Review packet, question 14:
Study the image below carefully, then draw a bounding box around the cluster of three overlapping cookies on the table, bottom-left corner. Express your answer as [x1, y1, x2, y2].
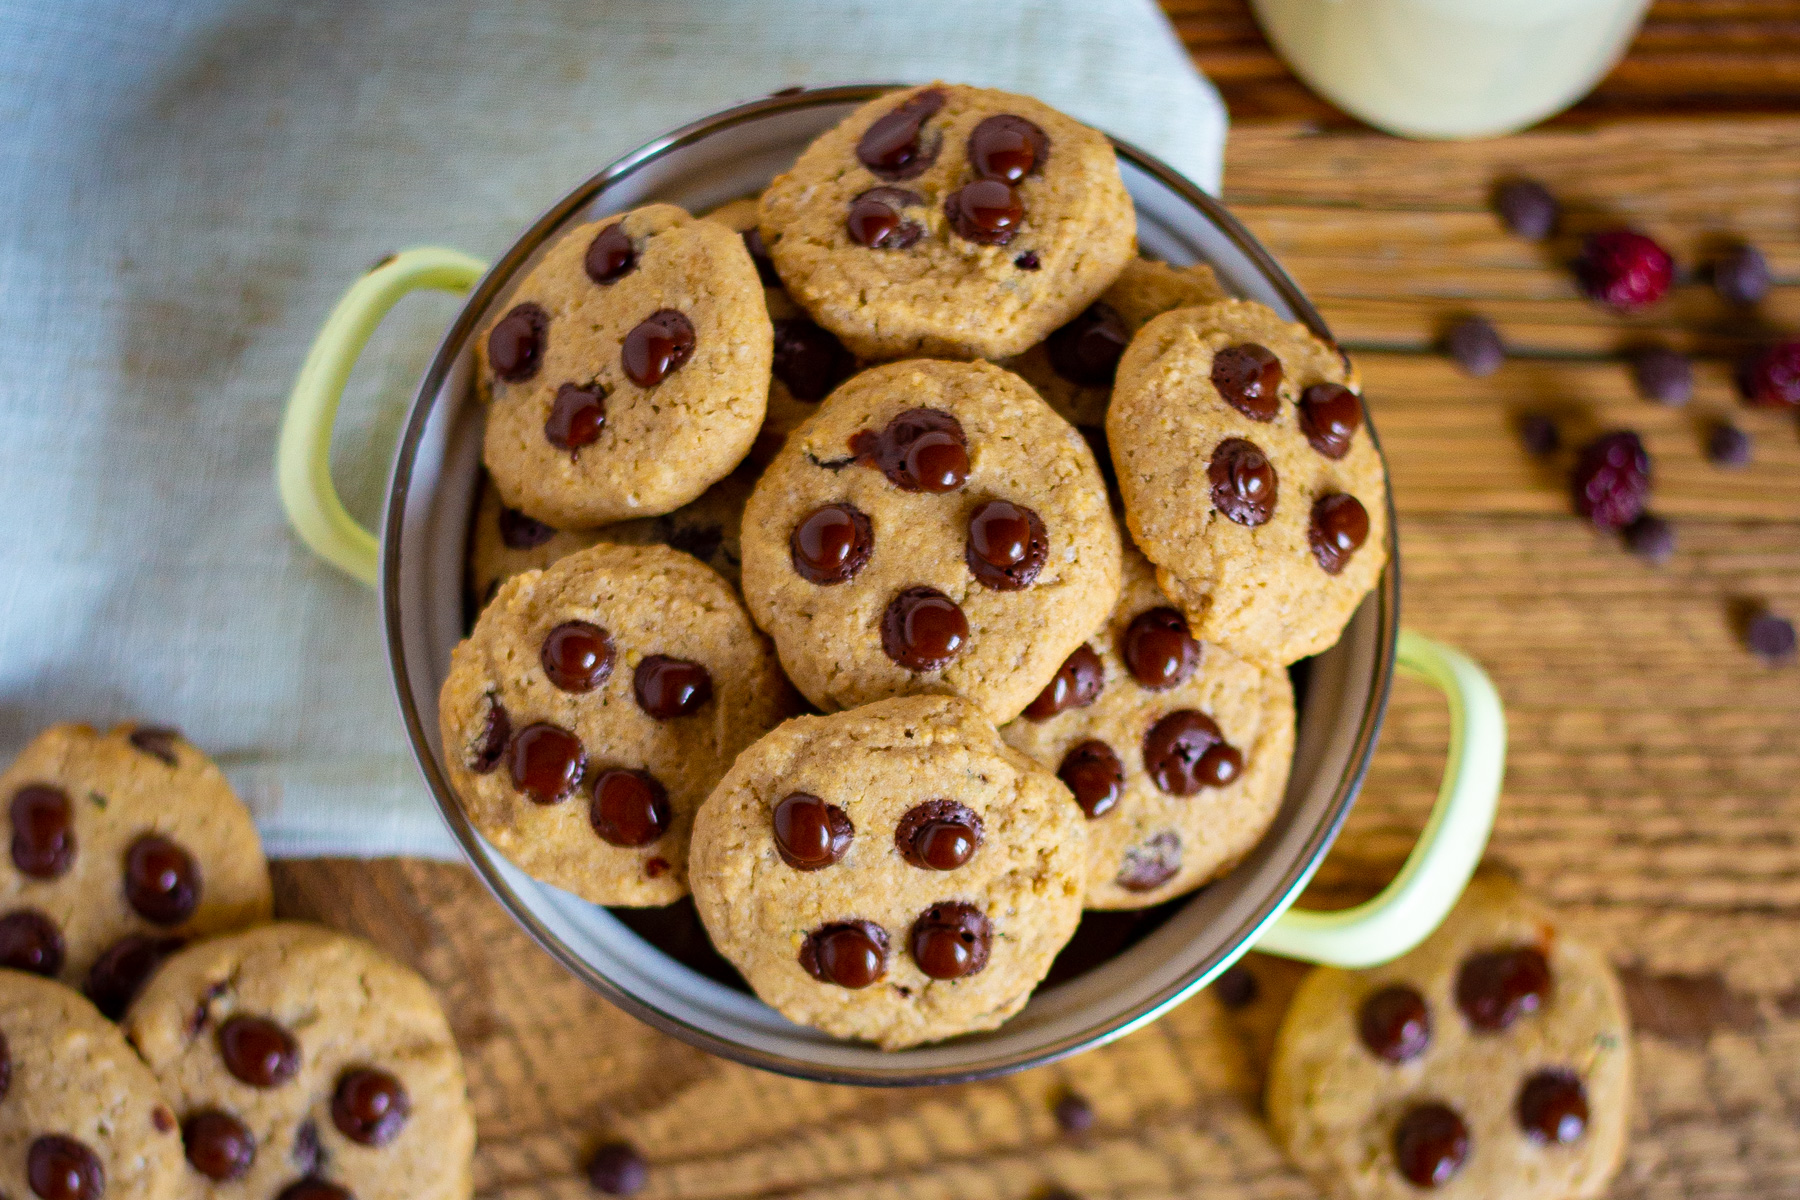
[0, 725, 475, 1200]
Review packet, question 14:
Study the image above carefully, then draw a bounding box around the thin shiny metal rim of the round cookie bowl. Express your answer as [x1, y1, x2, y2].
[380, 83, 1400, 1087]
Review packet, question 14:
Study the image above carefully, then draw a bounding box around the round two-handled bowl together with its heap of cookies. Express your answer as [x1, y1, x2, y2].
[277, 83, 1505, 1085]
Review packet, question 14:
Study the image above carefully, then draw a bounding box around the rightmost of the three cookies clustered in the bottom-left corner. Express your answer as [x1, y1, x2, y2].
[127, 921, 475, 1200]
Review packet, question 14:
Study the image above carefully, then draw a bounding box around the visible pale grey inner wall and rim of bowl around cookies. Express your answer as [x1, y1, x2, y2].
[383, 86, 1399, 1083]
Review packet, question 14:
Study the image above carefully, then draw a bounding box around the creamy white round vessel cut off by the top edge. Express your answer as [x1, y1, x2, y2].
[1251, 0, 1649, 139]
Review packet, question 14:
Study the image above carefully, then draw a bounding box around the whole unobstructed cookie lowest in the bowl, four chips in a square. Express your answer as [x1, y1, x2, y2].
[693, 696, 1085, 1051]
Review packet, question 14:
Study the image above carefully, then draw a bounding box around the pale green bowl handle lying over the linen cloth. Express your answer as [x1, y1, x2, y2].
[275, 246, 488, 587]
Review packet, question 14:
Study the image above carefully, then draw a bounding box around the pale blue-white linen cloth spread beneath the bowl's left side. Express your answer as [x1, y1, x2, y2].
[0, 0, 1226, 856]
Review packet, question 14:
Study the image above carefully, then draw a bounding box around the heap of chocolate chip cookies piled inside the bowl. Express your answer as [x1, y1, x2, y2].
[439, 85, 1388, 1049]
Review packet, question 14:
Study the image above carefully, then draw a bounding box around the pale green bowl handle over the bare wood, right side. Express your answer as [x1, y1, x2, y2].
[1256, 630, 1507, 966]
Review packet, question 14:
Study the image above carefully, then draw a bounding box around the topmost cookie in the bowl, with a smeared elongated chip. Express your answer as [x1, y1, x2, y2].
[760, 83, 1138, 358]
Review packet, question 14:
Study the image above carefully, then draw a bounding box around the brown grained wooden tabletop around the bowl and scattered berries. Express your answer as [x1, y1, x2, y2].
[277, 0, 1800, 1200]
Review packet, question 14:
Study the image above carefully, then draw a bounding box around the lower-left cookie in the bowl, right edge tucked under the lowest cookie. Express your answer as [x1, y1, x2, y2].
[439, 542, 788, 905]
